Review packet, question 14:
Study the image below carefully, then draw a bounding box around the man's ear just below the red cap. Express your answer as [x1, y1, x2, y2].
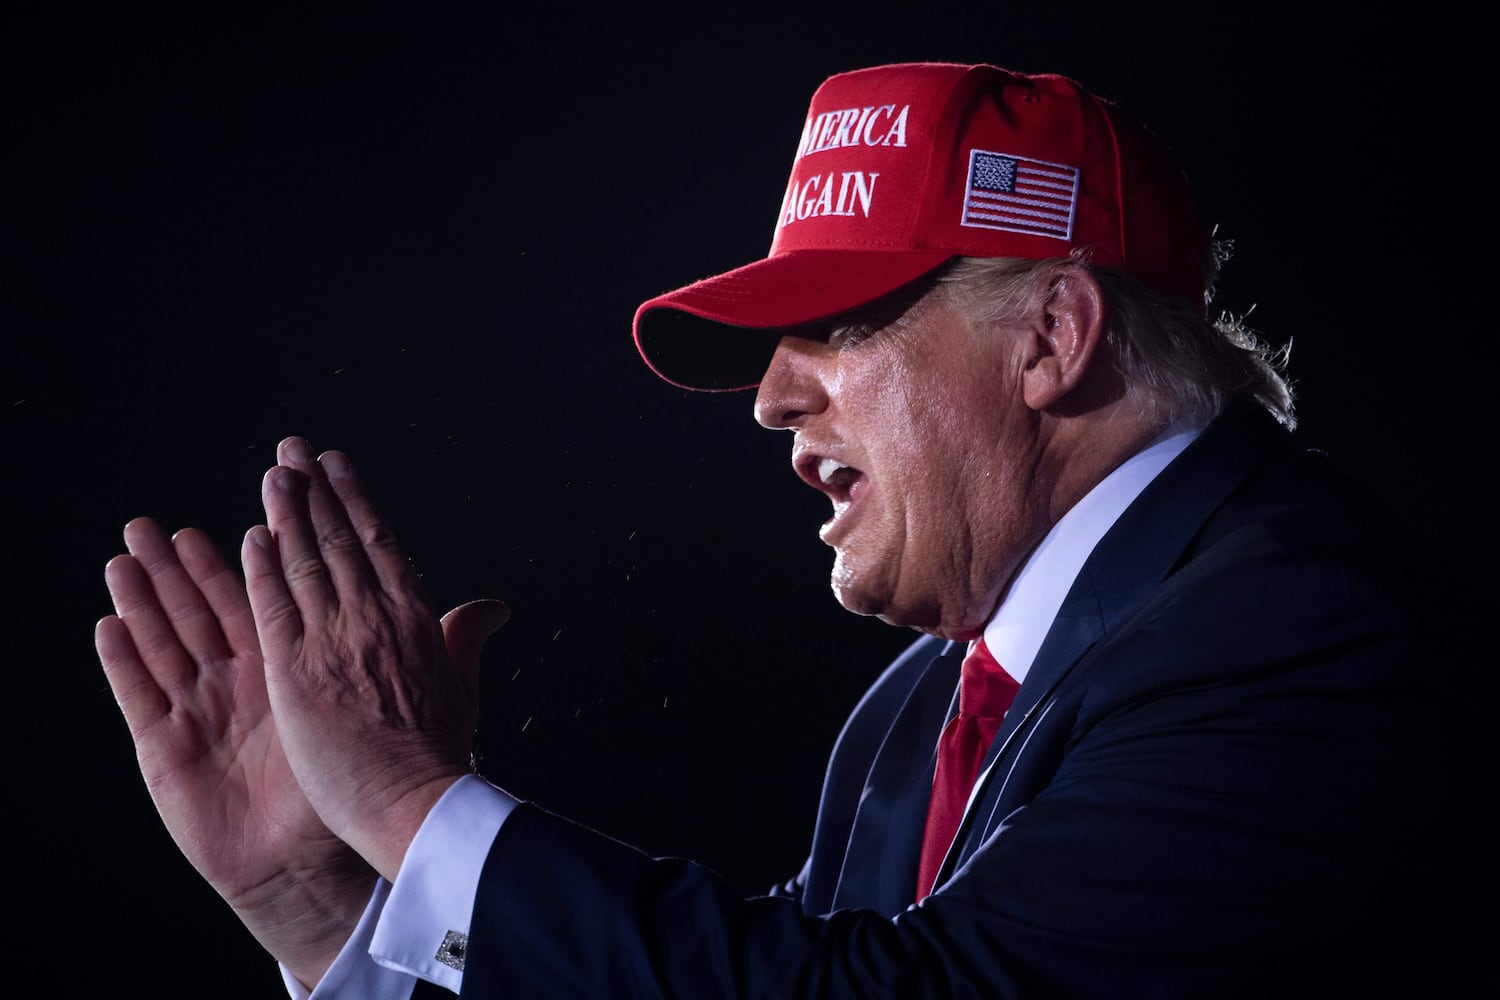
[1022, 267, 1106, 411]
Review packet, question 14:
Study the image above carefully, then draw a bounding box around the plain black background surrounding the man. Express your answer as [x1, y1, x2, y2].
[0, 3, 1494, 997]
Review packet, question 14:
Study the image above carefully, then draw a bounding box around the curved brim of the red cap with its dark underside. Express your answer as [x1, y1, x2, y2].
[635, 250, 953, 391]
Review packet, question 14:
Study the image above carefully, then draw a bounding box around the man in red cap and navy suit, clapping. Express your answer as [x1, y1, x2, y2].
[98, 64, 1490, 999]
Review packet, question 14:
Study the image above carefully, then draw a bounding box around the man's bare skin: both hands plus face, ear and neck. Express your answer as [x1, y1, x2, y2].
[96, 265, 1160, 987]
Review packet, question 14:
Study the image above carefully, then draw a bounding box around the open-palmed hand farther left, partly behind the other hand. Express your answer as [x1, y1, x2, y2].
[95, 517, 375, 985]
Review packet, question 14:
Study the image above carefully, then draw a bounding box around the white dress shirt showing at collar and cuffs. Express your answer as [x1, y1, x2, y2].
[292, 429, 1199, 1000]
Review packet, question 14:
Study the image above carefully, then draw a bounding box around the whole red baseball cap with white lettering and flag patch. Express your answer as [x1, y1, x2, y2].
[635, 63, 1209, 390]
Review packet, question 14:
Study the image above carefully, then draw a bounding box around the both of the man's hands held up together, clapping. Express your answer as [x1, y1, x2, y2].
[96, 438, 509, 988]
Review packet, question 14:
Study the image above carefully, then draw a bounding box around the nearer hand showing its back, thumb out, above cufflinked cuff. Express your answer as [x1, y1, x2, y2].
[242, 438, 509, 879]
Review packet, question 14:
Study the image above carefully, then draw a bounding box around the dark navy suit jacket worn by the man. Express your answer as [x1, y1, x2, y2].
[461, 406, 1496, 1000]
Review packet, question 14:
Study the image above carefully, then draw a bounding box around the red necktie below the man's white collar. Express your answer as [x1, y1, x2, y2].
[917, 639, 1020, 901]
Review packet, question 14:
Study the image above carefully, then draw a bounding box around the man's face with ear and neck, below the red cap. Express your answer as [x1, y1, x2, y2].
[756, 265, 1158, 639]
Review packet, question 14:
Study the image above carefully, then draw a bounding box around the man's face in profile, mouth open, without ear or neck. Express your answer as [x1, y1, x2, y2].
[756, 281, 1047, 639]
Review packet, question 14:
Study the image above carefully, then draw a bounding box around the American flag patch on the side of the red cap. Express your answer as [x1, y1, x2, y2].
[963, 150, 1079, 240]
